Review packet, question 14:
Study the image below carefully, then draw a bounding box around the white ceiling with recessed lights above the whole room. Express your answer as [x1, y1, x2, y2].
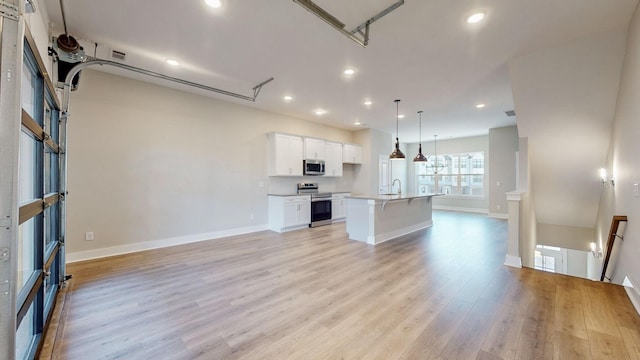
[38, 0, 637, 142]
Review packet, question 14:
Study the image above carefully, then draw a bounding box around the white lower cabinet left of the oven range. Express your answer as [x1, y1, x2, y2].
[269, 195, 311, 232]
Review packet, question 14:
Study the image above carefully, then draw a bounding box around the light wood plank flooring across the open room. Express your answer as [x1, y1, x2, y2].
[41, 212, 640, 360]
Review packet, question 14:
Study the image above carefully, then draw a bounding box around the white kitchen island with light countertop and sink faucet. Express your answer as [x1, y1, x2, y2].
[346, 194, 440, 245]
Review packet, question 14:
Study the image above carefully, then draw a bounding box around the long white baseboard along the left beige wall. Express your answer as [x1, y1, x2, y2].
[66, 224, 268, 264]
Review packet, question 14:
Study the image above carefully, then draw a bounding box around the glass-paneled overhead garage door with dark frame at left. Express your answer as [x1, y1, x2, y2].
[15, 30, 64, 359]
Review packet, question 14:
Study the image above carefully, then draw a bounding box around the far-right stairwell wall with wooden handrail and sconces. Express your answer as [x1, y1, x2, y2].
[592, 4, 640, 303]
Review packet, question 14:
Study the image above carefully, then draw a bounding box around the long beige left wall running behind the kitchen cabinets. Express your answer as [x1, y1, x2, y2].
[67, 70, 357, 260]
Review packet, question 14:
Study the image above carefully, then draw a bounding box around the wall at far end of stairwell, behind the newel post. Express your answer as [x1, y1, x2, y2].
[509, 28, 627, 227]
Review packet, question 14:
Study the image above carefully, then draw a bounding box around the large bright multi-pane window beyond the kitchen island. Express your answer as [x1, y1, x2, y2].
[415, 152, 485, 197]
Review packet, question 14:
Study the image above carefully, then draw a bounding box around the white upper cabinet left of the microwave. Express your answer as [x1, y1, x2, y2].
[268, 133, 303, 176]
